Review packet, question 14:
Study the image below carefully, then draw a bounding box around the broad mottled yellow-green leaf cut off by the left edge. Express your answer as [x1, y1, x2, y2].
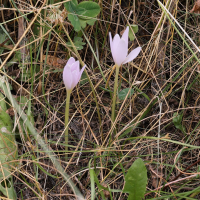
[0, 93, 17, 199]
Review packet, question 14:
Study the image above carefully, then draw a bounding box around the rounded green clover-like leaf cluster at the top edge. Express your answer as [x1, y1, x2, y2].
[64, 0, 100, 32]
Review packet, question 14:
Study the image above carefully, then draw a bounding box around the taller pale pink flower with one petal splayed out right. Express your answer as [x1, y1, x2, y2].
[109, 27, 141, 67]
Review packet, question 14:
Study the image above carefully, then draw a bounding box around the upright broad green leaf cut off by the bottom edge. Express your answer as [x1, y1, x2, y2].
[123, 158, 147, 200]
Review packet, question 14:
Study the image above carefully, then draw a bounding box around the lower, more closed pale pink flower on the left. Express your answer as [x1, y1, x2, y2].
[63, 57, 86, 91]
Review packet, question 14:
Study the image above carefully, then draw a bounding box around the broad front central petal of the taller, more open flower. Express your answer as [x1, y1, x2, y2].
[113, 38, 128, 67]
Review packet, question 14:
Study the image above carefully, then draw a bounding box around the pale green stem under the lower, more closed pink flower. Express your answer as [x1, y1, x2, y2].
[65, 90, 71, 161]
